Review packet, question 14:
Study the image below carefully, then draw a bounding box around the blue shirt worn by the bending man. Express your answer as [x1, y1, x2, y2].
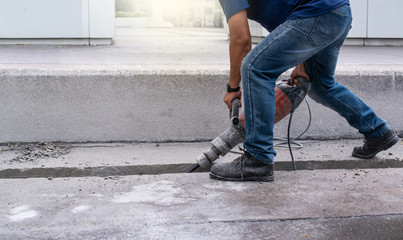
[220, 0, 350, 31]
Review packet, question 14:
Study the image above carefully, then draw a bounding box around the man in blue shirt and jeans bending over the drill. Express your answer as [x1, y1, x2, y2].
[210, 0, 399, 181]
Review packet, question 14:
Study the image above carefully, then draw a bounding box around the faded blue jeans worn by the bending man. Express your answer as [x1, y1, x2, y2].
[241, 5, 390, 163]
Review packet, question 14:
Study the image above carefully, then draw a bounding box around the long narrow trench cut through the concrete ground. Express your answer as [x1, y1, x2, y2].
[0, 159, 403, 179]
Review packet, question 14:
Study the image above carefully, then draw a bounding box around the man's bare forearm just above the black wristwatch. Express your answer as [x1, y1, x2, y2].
[229, 38, 252, 88]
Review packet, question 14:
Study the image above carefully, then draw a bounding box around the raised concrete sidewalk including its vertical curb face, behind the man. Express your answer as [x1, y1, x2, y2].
[0, 28, 403, 142]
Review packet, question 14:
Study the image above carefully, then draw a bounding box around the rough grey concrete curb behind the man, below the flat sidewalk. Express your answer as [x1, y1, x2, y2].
[0, 65, 403, 142]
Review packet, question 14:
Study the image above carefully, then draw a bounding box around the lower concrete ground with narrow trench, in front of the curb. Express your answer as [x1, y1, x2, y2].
[0, 140, 403, 240]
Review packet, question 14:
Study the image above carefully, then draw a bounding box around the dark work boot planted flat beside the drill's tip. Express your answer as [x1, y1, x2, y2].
[210, 151, 274, 182]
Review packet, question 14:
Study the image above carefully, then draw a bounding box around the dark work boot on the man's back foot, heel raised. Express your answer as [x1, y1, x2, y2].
[353, 130, 399, 159]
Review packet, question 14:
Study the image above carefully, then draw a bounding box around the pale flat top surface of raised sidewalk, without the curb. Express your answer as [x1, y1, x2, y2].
[0, 28, 403, 67]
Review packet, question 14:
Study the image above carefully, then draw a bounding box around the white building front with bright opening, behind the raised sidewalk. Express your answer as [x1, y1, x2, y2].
[0, 0, 403, 46]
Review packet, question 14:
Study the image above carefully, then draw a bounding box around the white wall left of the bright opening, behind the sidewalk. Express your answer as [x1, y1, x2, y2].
[0, 0, 115, 43]
